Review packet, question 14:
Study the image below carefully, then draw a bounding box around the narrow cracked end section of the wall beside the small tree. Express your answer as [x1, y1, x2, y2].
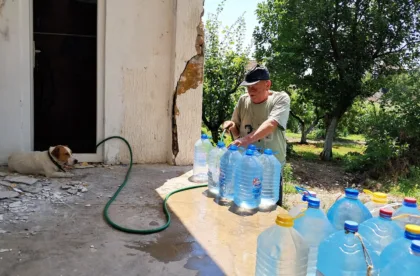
[170, 0, 204, 165]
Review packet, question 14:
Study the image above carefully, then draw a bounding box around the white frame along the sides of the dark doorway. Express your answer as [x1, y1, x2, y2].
[29, 0, 106, 162]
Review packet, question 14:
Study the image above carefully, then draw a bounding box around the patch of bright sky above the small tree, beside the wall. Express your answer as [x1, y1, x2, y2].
[203, 0, 263, 52]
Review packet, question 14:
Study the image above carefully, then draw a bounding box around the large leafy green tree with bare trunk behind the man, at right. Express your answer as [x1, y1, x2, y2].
[254, 0, 420, 160]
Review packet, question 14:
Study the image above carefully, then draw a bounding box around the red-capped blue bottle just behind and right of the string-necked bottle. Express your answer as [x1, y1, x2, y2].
[359, 208, 404, 256]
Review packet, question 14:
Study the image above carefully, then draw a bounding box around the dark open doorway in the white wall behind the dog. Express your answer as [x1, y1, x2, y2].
[33, 0, 97, 153]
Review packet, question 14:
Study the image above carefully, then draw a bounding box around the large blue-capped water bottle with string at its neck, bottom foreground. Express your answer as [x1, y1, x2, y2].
[317, 221, 379, 276]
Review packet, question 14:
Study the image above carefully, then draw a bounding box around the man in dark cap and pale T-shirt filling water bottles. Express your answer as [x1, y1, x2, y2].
[223, 65, 290, 206]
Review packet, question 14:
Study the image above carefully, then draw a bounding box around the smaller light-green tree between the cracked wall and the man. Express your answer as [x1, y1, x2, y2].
[202, 0, 250, 142]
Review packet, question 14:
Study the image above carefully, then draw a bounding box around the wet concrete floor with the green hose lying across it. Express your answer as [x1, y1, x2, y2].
[0, 165, 283, 276]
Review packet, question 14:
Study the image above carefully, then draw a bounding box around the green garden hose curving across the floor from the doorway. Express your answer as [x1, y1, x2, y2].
[96, 136, 207, 234]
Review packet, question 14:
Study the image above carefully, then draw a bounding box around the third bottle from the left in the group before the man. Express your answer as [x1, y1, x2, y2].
[219, 145, 242, 201]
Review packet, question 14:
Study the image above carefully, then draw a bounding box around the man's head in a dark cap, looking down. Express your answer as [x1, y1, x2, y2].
[241, 64, 271, 104]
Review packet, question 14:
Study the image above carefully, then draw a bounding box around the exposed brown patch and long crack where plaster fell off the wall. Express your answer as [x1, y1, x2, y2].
[172, 9, 204, 165]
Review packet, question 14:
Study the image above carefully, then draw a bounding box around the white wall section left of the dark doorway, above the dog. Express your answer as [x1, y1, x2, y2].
[0, 0, 32, 164]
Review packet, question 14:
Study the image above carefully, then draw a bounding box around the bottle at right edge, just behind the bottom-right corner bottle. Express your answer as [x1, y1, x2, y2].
[380, 224, 420, 268]
